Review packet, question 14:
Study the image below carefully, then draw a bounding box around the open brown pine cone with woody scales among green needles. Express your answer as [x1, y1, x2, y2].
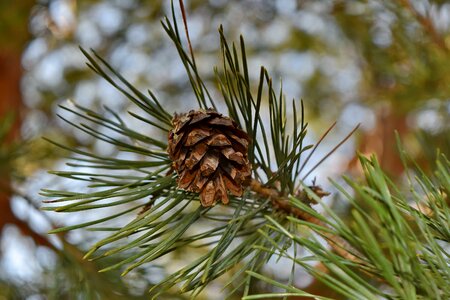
[167, 109, 251, 206]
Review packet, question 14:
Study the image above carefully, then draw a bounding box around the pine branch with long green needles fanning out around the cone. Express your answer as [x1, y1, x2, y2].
[41, 4, 364, 297]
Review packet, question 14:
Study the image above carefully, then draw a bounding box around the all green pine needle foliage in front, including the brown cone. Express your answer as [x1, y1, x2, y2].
[42, 1, 450, 299]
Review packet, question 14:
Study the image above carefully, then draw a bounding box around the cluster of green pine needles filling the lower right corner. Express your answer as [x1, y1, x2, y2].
[247, 149, 450, 299]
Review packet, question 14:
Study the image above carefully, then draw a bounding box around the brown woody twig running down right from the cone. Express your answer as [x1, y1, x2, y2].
[249, 179, 362, 264]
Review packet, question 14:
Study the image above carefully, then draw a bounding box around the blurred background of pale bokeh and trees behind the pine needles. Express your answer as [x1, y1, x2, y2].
[0, 0, 450, 300]
